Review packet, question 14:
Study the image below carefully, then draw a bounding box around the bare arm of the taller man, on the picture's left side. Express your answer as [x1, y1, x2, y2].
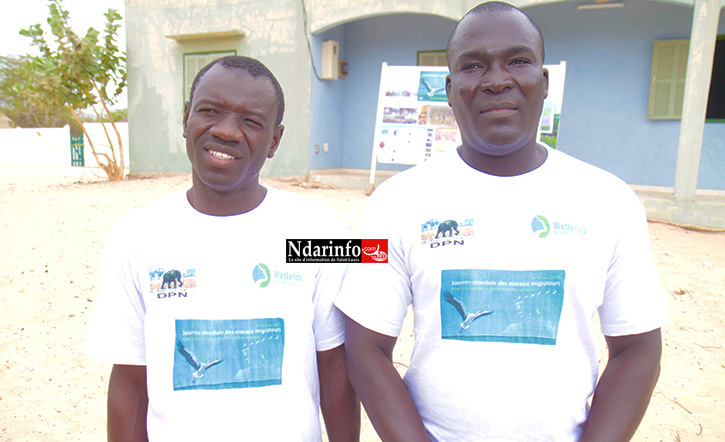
[345, 318, 430, 442]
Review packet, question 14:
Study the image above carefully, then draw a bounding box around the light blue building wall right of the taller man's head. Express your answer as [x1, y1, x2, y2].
[527, 2, 725, 189]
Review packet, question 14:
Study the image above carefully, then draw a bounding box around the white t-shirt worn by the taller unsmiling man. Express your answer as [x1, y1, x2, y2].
[336, 149, 667, 441]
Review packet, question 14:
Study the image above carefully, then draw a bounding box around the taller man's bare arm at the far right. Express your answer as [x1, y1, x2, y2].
[580, 328, 662, 442]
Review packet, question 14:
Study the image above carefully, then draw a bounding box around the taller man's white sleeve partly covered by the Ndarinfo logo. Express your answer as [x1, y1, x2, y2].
[335, 187, 412, 336]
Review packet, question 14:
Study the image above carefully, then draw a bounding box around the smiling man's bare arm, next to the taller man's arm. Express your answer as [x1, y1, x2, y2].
[317, 344, 360, 442]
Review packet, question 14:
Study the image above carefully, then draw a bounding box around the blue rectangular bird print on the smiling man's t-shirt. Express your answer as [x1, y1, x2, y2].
[173, 318, 284, 390]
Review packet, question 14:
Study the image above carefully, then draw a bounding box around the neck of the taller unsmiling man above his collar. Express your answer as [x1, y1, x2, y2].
[458, 143, 549, 176]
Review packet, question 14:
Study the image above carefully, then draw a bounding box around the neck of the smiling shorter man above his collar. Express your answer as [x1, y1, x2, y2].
[186, 182, 267, 216]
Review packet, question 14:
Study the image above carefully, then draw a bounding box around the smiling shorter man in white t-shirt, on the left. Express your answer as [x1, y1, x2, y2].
[85, 56, 360, 441]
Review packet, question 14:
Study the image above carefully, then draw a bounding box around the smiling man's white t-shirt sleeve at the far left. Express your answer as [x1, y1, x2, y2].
[83, 218, 146, 365]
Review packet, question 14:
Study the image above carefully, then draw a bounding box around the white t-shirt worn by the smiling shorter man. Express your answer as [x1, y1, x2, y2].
[84, 189, 345, 441]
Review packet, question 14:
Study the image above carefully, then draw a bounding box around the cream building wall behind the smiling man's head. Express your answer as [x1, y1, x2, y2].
[126, 0, 310, 175]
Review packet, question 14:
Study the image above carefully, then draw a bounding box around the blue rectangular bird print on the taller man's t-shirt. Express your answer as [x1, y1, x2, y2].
[440, 269, 565, 345]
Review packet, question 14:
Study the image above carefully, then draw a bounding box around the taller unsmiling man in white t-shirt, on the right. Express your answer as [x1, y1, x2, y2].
[335, 2, 667, 442]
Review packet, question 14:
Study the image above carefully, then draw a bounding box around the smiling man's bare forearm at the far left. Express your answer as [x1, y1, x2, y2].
[108, 364, 149, 442]
